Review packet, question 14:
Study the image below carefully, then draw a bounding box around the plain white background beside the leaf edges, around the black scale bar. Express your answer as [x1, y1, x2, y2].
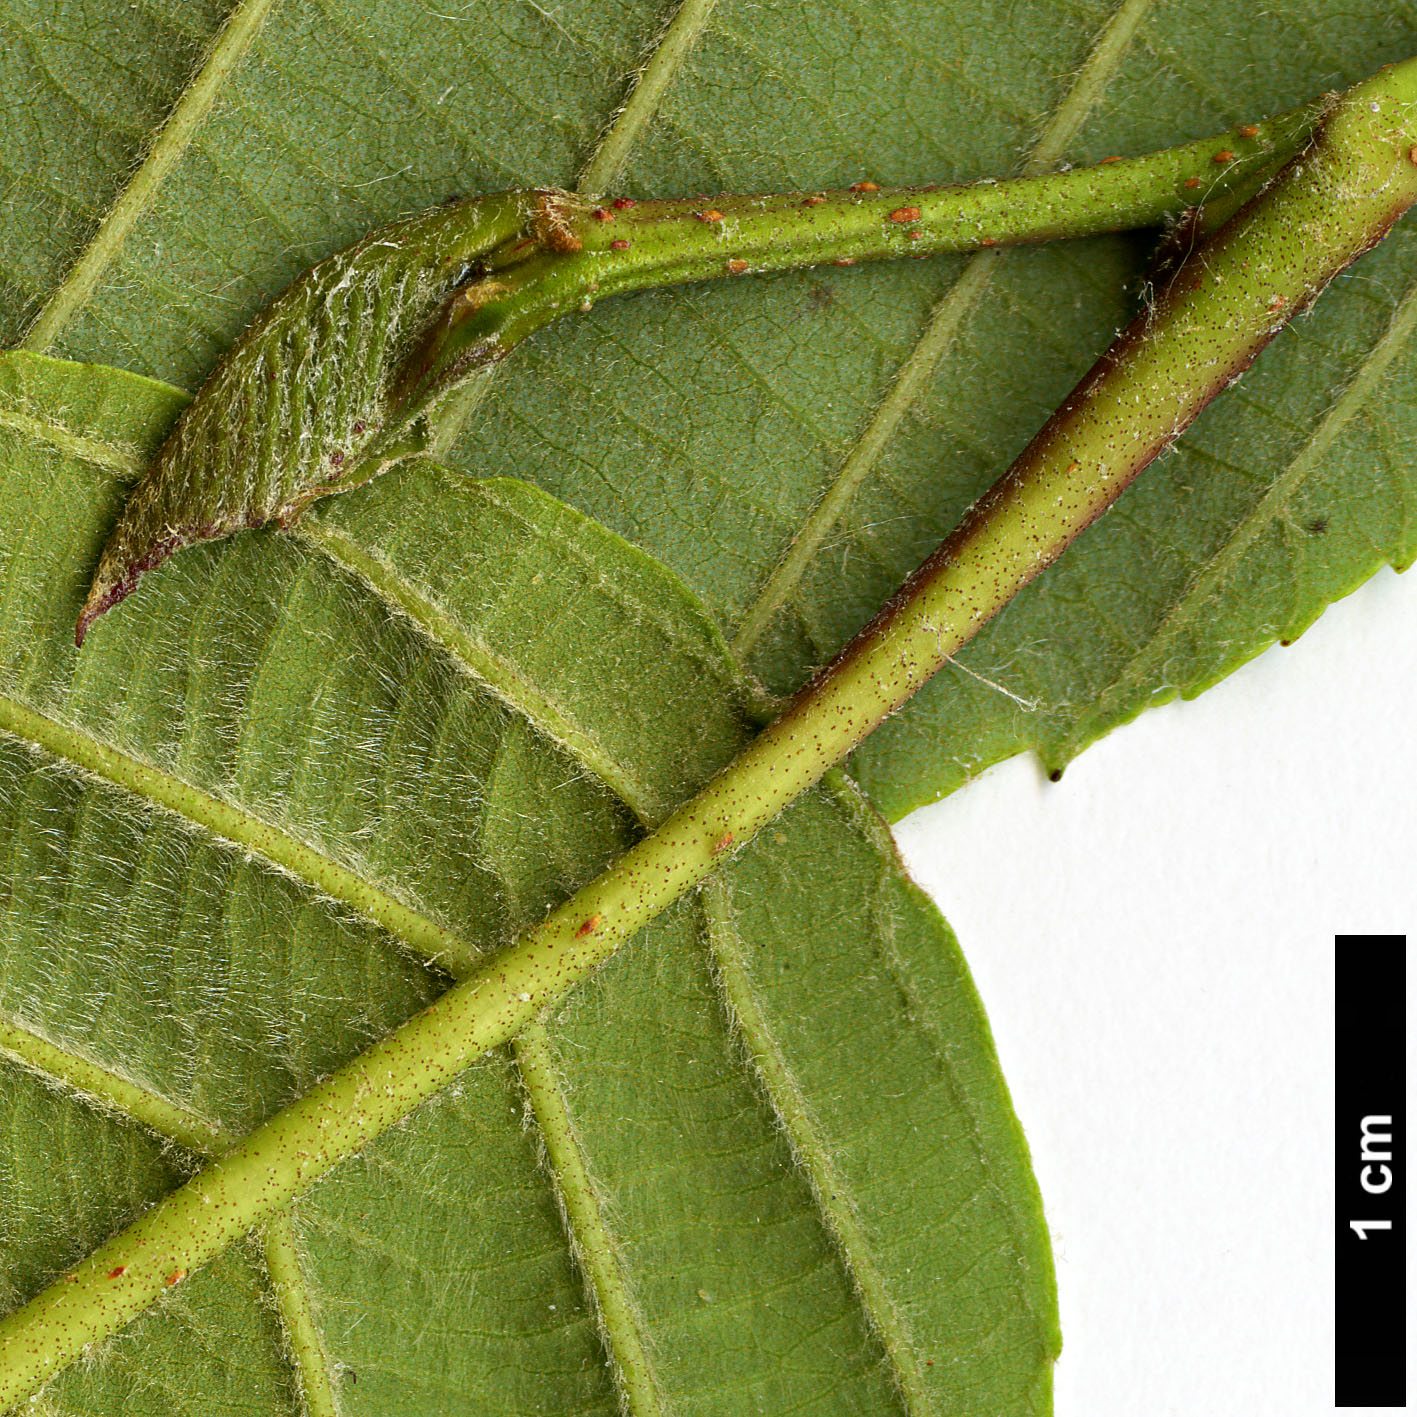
[897, 558, 1417, 1417]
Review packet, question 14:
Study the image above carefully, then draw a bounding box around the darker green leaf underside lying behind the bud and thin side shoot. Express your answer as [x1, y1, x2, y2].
[4, 0, 1417, 816]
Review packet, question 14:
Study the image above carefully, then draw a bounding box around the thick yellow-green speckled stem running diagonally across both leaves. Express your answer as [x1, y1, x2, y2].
[0, 52, 1417, 1410]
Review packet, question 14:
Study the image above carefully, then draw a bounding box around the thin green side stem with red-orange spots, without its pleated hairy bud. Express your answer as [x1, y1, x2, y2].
[404, 102, 1323, 411]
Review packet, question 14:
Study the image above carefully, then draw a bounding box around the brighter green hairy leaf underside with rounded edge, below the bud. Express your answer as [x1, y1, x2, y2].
[0, 354, 1057, 1413]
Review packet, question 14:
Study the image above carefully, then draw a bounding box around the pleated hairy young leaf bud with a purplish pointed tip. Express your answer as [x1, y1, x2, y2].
[75, 194, 530, 645]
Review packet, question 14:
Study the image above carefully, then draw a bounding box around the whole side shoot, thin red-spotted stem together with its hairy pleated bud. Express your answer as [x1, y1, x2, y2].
[75, 94, 1321, 645]
